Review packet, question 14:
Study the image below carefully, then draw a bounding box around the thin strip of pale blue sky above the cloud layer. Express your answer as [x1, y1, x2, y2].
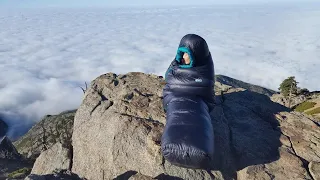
[0, 0, 318, 8]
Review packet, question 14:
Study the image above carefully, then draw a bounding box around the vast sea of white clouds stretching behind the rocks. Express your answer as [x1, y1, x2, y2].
[0, 7, 320, 137]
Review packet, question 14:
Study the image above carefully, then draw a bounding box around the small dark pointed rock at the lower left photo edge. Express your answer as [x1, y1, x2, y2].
[0, 136, 21, 160]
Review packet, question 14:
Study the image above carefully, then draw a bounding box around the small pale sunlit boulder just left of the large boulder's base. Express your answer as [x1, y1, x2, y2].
[31, 143, 72, 175]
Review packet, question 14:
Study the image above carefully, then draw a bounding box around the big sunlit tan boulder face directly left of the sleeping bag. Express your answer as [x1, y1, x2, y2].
[72, 73, 165, 179]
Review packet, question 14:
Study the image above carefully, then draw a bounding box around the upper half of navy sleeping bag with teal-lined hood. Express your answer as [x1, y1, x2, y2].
[163, 34, 215, 111]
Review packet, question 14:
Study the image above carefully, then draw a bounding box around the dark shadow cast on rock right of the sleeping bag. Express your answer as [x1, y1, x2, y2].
[211, 91, 290, 179]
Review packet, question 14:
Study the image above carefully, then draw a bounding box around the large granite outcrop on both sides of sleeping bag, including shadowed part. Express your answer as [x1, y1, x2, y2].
[66, 73, 320, 179]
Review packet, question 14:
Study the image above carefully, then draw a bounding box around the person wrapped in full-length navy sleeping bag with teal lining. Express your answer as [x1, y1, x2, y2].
[161, 34, 214, 169]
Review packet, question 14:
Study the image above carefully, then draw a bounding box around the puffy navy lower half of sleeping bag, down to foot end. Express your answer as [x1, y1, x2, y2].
[161, 96, 214, 169]
